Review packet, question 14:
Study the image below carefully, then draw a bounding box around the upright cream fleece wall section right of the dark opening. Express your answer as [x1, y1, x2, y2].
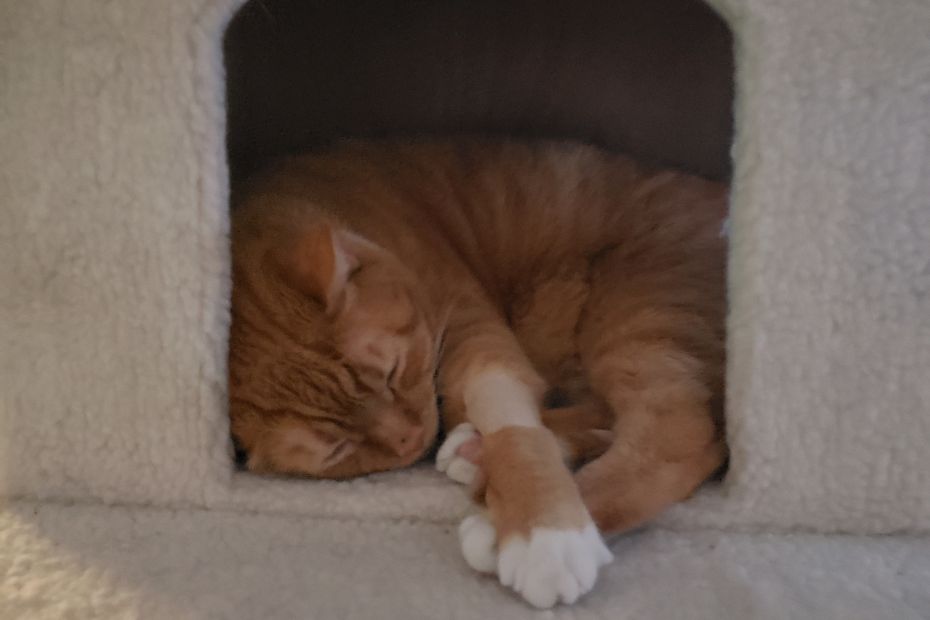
[719, 0, 930, 532]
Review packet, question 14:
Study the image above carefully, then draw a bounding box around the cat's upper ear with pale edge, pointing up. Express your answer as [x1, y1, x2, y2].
[279, 222, 359, 312]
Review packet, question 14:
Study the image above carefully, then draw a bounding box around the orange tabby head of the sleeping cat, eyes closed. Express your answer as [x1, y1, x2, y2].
[229, 213, 441, 478]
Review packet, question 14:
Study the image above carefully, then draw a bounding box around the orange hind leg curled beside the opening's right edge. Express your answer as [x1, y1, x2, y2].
[576, 216, 726, 532]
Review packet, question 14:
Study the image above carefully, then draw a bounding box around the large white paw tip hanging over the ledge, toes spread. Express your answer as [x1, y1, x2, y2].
[496, 523, 613, 609]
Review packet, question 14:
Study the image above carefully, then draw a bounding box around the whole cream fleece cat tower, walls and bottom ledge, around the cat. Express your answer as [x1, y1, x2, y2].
[0, 0, 930, 620]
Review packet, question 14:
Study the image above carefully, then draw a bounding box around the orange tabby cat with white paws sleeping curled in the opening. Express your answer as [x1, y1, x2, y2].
[229, 139, 726, 607]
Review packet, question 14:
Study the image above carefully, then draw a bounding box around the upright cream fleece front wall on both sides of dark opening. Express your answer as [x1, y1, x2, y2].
[0, 0, 930, 588]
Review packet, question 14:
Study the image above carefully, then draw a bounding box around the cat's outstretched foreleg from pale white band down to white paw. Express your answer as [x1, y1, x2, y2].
[460, 368, 612, 608]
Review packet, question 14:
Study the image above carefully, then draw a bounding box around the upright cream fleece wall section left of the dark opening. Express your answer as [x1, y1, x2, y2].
[0, 0, 233, 502]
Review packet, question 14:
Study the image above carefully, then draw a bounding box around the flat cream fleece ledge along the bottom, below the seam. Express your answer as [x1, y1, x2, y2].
[0, 502, 930, 620]
